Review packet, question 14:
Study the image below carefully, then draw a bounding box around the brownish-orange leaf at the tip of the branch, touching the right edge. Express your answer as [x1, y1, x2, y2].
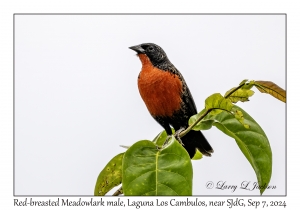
[255, 81, 286, 102]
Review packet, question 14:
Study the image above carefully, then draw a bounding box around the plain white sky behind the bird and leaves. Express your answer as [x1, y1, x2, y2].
[15, 15, 286, 195]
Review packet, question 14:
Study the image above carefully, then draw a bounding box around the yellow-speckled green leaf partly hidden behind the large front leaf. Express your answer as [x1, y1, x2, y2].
[94, 153, 124, 196]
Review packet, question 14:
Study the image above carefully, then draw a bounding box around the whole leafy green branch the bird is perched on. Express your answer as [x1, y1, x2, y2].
[94, 80, 286, 195]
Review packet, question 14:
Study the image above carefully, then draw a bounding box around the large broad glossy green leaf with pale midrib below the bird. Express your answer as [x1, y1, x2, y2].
[123, 136, 193, 195]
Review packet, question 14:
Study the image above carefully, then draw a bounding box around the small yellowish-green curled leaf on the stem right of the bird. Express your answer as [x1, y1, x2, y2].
[205, 93, 233, 115]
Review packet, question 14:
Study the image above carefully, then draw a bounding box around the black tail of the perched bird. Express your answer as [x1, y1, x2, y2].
[181, 130, 214, 158]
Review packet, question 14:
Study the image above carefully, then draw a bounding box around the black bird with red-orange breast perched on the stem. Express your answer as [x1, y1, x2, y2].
[129, 43, 213, 158]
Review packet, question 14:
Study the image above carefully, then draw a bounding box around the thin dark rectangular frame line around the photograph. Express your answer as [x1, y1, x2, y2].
[13, 13, 287, 197]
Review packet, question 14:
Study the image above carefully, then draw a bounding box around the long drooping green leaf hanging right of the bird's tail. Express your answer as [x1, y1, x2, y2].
[214, 106, 272, 194]
